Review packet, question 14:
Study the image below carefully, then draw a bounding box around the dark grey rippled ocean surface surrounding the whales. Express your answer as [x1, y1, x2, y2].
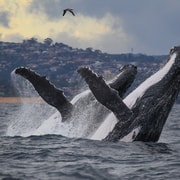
[0, 104, 180, 180]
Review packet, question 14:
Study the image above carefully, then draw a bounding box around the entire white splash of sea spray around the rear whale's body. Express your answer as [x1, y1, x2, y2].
[7, 72, 108, 138]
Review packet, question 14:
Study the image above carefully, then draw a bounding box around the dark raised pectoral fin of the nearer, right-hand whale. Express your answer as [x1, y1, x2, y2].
[78, 67, 132, 121]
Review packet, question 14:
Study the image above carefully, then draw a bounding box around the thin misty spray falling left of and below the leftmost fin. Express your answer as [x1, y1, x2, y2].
[6, 71, 55, 136]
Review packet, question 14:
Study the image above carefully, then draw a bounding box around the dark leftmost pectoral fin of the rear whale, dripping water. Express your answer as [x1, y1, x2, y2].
[15, 68, 73, 117]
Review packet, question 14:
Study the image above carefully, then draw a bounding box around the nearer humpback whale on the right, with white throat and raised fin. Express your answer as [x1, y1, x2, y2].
[78, 47, 180, 142]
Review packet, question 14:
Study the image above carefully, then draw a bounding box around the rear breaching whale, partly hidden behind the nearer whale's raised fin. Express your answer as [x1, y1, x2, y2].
[15, 65, 137, 137]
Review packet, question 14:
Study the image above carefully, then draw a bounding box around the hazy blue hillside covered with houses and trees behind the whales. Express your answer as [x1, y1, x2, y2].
[0, 38, 167, 96]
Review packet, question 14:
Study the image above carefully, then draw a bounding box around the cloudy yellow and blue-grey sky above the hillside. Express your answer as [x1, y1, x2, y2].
[0, 0, 180, 55]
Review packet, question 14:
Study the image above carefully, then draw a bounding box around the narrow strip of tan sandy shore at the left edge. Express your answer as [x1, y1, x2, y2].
[0, 97, 44, 104]
